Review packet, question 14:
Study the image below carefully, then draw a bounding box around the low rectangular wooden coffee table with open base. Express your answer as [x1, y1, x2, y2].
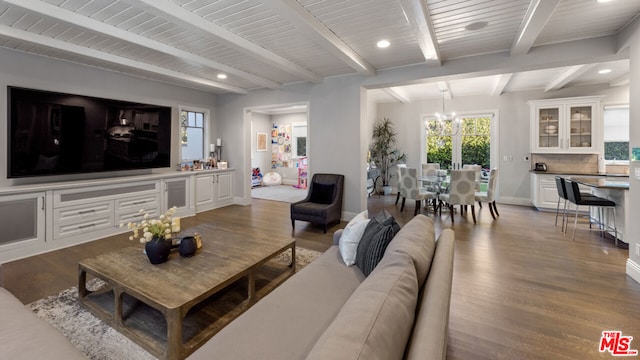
[78, 230, 296, 359]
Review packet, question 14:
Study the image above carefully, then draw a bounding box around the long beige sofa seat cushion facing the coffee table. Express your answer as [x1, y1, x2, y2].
[189, 246, 364, 360]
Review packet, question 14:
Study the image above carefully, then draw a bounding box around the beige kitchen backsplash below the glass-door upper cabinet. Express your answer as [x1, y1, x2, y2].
[531, 154, 598, 174]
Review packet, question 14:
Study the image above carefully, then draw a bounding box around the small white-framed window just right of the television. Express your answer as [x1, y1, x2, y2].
[180, 110, 206, 161]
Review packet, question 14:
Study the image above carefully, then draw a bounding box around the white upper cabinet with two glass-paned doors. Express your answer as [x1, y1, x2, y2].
[529, 96, 602, 154]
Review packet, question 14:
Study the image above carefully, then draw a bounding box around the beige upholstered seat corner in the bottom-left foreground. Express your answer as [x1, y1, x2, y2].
[0, 288, 86, 360]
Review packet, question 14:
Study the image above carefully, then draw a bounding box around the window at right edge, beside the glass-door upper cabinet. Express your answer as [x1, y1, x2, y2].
[603, 105, 629, 162]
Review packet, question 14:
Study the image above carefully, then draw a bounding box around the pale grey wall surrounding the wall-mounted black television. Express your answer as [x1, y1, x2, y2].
[0, 48, 216, 187]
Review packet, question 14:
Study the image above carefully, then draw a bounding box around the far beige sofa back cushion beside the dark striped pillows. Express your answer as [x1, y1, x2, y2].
[386, 214, 436, 286]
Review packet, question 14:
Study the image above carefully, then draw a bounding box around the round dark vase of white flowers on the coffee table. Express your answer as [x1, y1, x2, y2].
[120, 206, 180, 265]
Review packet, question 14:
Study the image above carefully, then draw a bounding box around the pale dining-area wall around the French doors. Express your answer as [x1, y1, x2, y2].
[377, 85, 629, 205]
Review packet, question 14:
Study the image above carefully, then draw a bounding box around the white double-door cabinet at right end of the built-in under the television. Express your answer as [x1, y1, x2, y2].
[195, 171, 233, 212]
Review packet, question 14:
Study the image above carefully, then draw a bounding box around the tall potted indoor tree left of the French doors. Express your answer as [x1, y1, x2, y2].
[369, 118, 407, 195]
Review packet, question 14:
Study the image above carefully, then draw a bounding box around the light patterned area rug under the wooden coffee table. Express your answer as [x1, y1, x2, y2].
[27, 248, 320, 360]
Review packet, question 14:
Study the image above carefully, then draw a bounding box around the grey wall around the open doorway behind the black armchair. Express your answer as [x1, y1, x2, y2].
[216, 76, 366, 217]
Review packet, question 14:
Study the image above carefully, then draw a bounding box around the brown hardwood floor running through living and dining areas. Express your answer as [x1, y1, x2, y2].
[3, 195, 640, 360]
